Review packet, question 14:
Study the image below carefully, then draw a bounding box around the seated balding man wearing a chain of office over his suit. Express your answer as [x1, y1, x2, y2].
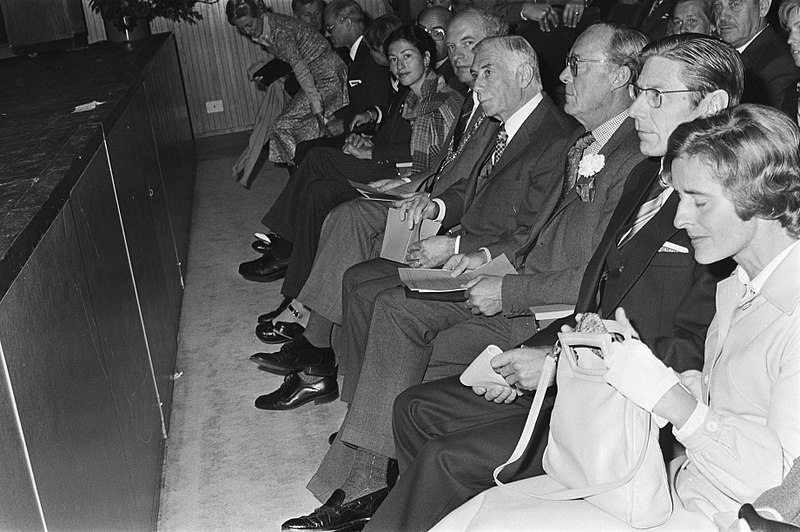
[251, 10, 508, 390]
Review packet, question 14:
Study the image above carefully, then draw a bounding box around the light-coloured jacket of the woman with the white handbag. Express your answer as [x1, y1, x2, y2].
[675, 246, 800, 528]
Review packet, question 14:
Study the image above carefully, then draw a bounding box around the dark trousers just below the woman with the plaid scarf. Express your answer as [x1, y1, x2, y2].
[261, 148, 396, 297]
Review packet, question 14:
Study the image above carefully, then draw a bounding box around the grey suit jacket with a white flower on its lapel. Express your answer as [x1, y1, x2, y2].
[504, 118, 644, 318]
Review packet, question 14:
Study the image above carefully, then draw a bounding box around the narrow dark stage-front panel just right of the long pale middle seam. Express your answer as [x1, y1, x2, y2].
[106, 89, 183, 428]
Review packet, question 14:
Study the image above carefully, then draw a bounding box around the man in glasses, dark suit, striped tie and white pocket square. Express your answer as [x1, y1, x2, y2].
[371, 35, 744, 530]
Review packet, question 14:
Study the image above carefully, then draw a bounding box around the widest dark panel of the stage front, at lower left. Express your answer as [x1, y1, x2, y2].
[0, 203, 140, 530]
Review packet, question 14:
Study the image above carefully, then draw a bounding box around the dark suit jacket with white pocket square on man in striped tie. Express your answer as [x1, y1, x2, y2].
[524, 158, 735, 371]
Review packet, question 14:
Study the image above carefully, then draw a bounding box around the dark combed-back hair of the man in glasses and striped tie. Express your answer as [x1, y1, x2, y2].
[639, 33, 744, 105]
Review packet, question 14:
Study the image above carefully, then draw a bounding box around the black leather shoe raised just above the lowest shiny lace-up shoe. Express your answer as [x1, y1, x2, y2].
[250, 334, 336, 376]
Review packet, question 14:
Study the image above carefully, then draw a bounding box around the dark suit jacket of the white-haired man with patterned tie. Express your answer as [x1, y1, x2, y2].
[438, 93, 576, 256]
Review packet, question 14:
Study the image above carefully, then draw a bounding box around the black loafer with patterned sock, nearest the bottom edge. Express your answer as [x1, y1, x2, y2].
[281, 488, 389, 532]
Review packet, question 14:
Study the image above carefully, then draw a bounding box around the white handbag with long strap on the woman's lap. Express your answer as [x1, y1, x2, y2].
[494, 321, 672, 528]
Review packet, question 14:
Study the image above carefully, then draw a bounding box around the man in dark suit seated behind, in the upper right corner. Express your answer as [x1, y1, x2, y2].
[714, 0, 800, 113]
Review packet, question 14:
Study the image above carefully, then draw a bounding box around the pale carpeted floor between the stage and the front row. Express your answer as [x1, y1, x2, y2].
[159, 134, 345, 531]
